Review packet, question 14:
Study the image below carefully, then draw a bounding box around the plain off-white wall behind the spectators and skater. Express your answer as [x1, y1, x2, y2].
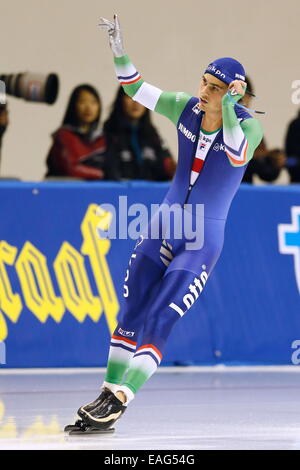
[0, 0, 300, 180]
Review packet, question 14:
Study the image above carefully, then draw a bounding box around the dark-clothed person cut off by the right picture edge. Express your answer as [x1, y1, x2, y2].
[285, 111, 300, 183]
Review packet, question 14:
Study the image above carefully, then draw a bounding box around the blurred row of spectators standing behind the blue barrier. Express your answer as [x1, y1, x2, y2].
[0, 77, 300, 184]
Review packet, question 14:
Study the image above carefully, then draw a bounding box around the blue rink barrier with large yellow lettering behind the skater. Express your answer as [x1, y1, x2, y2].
[0, 182, 300, 368]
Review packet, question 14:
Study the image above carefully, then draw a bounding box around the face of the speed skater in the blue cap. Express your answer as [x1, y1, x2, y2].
[198, 73, 228, 113]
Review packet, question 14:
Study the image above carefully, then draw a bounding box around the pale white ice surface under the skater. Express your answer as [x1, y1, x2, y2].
[0, 366, 300, 451]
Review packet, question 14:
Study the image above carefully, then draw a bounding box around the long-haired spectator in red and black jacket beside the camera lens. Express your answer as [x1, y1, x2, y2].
[46, 85, 110, 180]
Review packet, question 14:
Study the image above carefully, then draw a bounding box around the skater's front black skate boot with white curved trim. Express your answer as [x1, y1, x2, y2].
[82, 392, 126, 430]
